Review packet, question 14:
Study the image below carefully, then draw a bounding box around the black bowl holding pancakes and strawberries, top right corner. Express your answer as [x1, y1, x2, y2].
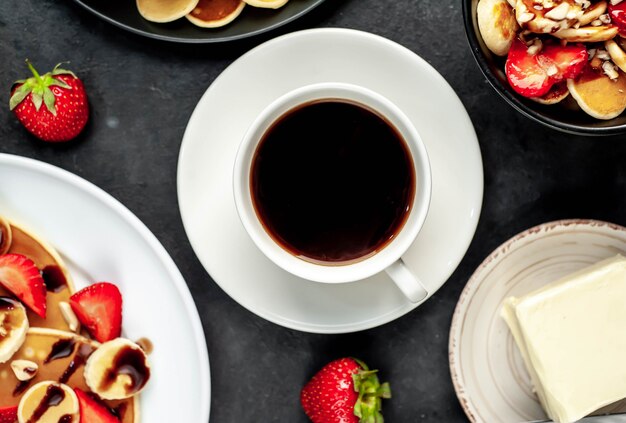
[463, 0, 626, 135]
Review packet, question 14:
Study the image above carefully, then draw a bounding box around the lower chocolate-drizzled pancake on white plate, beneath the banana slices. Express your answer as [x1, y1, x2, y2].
[0, 328, 139, 423]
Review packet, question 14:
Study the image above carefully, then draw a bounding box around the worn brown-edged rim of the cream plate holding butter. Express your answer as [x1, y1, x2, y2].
[448, 219, 626, 423]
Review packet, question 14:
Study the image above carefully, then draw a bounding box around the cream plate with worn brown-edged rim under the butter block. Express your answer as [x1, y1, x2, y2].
[450, 220, 626, 423]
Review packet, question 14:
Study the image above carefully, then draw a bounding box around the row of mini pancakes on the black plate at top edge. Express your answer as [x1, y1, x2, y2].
[137, 0, 289, 28]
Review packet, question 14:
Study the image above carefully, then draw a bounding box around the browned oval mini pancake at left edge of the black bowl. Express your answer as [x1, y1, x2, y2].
[478, 0, 519, 56]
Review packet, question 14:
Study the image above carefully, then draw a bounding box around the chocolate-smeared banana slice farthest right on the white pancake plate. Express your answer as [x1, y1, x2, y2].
[85, 338, 150, 400]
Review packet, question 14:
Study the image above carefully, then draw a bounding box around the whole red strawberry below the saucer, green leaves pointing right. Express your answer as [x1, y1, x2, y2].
[300, 358, 391, 423]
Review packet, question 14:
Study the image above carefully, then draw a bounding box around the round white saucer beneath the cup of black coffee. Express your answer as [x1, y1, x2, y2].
[178, 28, 483, 333]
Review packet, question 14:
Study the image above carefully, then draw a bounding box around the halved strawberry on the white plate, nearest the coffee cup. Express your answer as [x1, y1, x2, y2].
[70, 282, 122, 342]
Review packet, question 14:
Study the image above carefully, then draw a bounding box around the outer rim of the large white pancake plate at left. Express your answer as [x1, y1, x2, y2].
[0, 153, 211, 423]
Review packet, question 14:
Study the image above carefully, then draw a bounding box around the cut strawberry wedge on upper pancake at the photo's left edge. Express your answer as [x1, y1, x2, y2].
[0, 254, 47, 318]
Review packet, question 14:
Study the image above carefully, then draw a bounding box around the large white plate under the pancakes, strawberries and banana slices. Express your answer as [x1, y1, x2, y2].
[0, 154, 210, 423]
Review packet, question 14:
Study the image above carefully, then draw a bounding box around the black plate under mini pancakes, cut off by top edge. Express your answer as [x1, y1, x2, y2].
[74, 0, 324, 43]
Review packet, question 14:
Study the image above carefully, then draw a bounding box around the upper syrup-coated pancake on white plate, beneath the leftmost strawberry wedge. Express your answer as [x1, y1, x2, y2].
[0, 218, 75, 330]
